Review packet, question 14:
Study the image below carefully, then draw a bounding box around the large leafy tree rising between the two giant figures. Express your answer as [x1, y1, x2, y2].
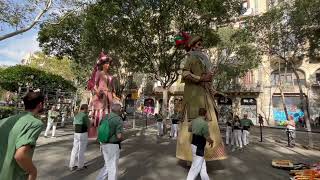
[39, 0, 245, 116]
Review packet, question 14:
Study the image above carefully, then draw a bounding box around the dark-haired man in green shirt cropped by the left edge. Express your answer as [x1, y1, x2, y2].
[0, 92, 44, 180]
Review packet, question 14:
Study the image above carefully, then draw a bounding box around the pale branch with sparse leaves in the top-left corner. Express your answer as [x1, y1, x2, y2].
[0, 0, 90, 41]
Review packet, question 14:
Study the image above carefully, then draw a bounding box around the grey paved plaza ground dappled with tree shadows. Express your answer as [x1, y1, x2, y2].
[34, 127, 320, 180]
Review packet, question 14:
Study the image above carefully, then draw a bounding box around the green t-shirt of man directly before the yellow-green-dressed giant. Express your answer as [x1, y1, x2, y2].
[191, 116, 209, 138]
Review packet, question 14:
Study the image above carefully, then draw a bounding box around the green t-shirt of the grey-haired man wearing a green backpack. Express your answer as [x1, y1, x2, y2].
[107, 112, 123, 143]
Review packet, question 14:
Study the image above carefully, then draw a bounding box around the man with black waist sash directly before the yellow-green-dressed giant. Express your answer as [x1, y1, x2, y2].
[187, 108, 213, 180]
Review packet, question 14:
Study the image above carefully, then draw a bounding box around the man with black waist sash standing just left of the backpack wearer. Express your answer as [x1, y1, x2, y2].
[69, 104, 90, 171]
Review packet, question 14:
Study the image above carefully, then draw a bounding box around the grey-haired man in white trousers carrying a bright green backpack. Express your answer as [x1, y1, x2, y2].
[97, 104, 123, 180]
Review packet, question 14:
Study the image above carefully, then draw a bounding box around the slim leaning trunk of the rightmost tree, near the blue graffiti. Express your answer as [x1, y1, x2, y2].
[293, 68, 313, 148]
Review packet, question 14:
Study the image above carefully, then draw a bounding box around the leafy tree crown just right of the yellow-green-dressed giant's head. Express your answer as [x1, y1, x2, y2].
[212, 27, 261, 92]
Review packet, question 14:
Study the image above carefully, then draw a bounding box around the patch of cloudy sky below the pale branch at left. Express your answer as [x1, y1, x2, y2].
[0, 29, 40, 66]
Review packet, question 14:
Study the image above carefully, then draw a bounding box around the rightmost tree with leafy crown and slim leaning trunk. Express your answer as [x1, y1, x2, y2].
[249, 0, 320, 147]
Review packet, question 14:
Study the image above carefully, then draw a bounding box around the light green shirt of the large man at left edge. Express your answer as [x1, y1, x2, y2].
[0, 112, 43, 180]
